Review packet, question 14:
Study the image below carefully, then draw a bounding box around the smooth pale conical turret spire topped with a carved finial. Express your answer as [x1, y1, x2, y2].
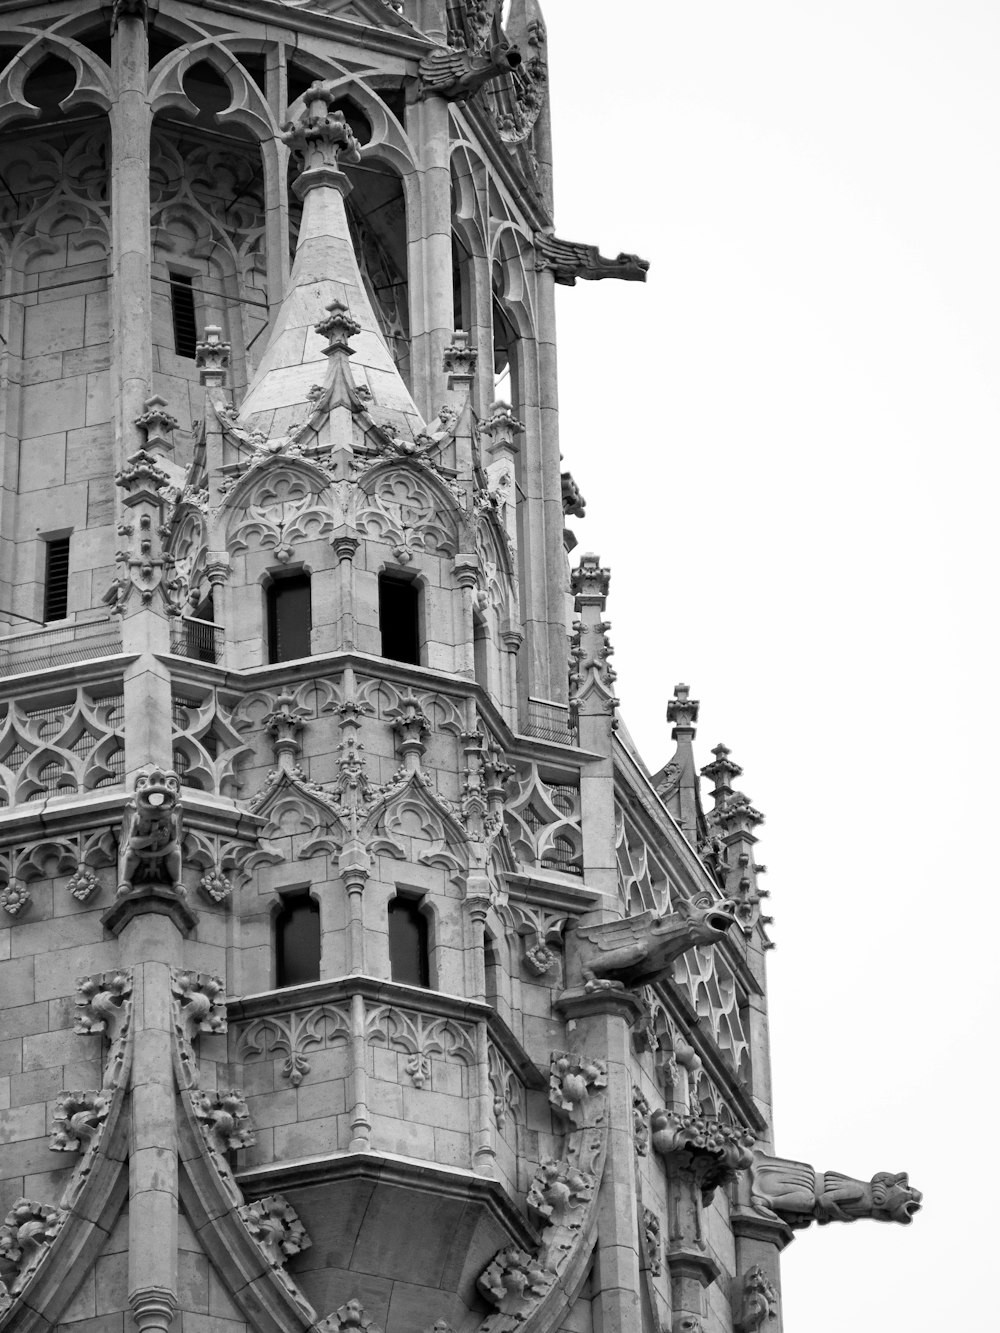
[240, 81, 423, 439]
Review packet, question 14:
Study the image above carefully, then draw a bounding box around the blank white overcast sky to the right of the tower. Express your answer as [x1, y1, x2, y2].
[545, 0, 1000, 1333]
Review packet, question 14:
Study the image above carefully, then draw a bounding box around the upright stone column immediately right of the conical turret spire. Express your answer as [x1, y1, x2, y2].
[407, 96, 455, 421]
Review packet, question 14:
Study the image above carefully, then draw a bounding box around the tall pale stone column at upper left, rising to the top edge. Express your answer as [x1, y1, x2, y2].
[109, 4, 153, 467]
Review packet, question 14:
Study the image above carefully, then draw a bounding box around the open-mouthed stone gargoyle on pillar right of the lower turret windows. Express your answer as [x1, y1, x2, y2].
[576, 898, 736, 990]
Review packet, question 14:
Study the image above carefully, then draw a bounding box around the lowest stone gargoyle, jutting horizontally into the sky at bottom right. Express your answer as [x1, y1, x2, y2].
[751, 1153, 923, 1228]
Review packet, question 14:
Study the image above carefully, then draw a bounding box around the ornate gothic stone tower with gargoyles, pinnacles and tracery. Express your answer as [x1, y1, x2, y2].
[0, 0, 920, 1333]
